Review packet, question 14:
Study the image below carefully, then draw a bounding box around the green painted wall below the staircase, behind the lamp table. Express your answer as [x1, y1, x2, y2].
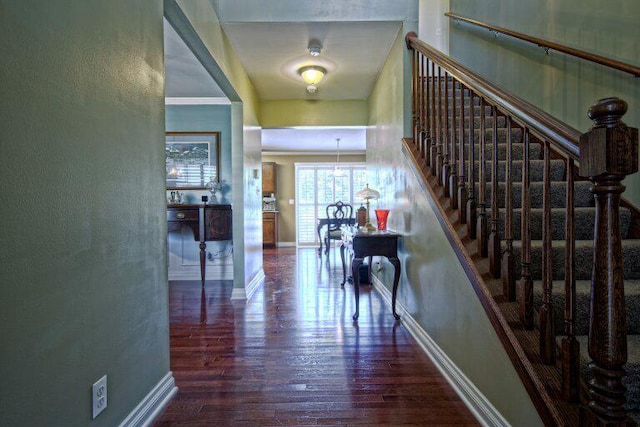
[367, 27, 542, 426]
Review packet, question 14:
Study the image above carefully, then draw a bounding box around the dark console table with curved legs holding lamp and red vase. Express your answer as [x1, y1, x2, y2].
[340, 227, 400, 320]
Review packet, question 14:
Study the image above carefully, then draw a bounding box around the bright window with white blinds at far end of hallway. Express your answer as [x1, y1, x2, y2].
[296, 163, 367, 246]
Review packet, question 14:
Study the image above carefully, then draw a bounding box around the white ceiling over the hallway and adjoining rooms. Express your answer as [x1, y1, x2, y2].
[160, 0, 409, 153]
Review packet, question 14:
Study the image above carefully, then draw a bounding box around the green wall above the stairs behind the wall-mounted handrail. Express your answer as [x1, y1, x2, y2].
[449, 0, 640, 206]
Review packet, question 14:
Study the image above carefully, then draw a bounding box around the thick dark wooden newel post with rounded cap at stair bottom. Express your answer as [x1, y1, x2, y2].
[580, 98, 638, 426]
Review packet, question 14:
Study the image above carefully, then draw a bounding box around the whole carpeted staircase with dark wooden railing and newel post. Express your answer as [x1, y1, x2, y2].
[404, 33, 640, 426]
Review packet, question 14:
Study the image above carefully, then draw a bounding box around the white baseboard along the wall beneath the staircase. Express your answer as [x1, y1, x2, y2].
[371, 275, 510, 427]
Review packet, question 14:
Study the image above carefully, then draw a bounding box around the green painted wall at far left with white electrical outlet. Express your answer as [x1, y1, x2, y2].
[0, 0, 169, 426]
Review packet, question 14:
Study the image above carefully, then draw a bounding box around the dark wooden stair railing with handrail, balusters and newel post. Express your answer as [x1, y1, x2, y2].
[405, 32, 638, 426]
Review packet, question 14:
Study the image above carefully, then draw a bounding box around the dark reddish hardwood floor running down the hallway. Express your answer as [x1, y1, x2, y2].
[154, 248, 479, 427]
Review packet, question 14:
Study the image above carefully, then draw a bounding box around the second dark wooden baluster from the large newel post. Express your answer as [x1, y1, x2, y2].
[539, 141, 556, 365]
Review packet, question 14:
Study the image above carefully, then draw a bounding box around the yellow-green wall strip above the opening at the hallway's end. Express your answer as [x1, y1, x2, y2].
[260, 100, 368, 128]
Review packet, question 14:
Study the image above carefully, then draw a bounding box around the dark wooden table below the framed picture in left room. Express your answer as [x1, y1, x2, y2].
[167, 204, 232, 286]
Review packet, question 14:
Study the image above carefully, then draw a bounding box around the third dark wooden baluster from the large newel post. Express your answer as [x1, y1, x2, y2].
[518, 127, 533, 329]
